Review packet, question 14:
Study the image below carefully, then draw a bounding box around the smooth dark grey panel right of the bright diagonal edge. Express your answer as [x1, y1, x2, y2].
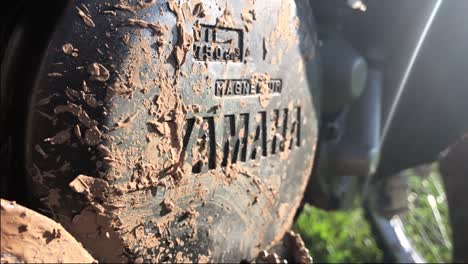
[378, 1, 468, 175]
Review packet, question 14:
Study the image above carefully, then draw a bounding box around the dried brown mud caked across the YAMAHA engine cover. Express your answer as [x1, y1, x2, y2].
[21, 0, 315, 262]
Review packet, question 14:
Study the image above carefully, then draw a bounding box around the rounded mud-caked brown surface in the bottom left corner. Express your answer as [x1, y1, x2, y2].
[0, 199, 97, 263]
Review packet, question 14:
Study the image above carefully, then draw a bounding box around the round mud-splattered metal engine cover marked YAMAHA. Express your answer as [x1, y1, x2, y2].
[25, 0, 318, 262]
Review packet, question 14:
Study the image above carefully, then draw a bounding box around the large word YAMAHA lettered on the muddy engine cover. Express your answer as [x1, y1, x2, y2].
[183, 106, 302, 173]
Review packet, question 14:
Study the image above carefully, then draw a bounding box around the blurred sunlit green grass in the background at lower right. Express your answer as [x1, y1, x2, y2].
[294, 165, 452, 263]
